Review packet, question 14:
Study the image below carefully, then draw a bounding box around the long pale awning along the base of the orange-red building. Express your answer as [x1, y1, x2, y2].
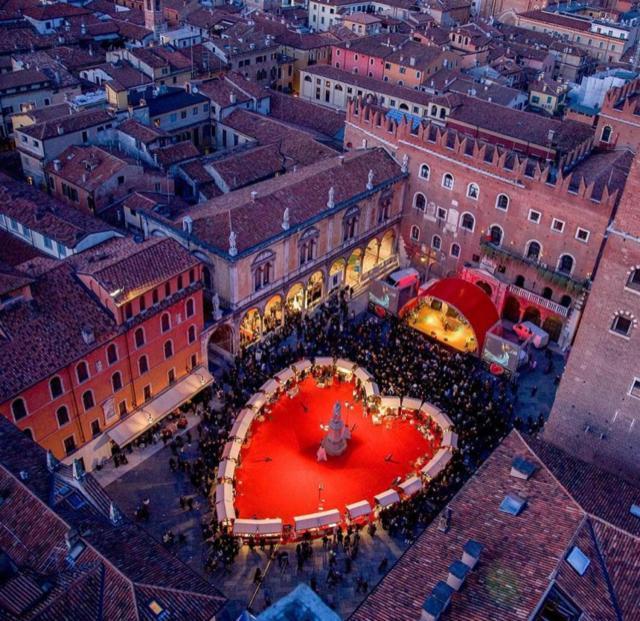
[107, 367, 213, 447]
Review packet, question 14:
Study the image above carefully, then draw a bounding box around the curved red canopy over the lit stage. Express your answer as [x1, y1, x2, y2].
[423, 278, 500, 354]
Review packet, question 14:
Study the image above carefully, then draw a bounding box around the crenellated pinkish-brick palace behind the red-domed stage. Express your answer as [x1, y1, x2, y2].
[345, 103, 632, 345]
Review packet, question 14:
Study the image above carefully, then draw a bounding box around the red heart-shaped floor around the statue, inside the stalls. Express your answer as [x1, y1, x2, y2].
[235, 377, 438, 524]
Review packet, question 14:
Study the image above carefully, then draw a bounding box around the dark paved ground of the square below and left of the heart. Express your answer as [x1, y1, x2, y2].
[107, 434, 408, 620]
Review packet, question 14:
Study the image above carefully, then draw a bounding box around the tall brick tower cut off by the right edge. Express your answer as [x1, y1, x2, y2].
[545, 149, 640, 480]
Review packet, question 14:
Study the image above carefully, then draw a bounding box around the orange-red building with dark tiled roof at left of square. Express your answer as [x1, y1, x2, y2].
[0, 239, 208, 469]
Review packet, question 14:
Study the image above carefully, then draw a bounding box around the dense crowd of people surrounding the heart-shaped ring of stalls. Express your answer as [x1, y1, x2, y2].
[154, 291, 539, 604]
